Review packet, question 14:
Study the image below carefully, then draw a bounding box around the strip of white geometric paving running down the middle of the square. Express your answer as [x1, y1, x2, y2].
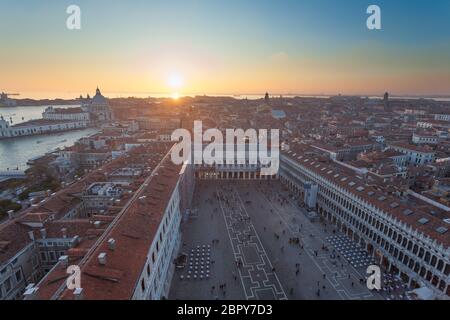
[216, 188, 287, 300]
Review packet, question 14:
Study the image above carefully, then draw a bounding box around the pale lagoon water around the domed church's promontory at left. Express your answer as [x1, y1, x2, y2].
[0, 106, 98, 171]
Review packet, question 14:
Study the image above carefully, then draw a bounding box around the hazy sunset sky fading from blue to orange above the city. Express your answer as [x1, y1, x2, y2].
[0, 0, 450, 97]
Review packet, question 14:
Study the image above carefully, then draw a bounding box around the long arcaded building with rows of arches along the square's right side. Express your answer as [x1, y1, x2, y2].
[280, 153, 450, 295]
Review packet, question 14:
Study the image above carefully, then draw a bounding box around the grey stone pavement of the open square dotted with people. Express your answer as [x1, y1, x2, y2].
[169, 181, 382, 300]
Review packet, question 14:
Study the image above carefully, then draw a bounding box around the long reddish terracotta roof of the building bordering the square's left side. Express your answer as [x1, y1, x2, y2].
[60, 158, 181, 300]
